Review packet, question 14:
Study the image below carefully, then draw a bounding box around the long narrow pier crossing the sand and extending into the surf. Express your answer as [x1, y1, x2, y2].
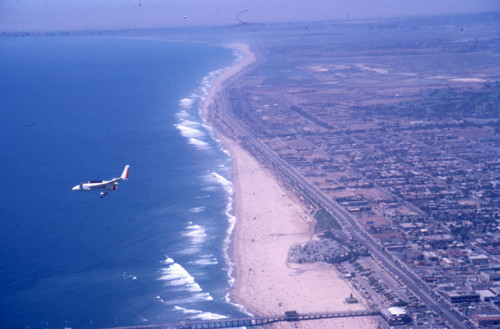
[104, 310, 380, 329]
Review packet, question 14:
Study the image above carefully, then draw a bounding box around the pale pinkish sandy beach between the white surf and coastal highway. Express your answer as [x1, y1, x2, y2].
[202, 44, 379, 328]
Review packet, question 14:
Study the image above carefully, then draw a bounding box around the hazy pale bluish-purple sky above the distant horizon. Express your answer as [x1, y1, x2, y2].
[0, 0, 500, 31]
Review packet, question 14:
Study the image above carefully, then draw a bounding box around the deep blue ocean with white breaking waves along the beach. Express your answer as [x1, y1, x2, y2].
[0, 37, 246, 328]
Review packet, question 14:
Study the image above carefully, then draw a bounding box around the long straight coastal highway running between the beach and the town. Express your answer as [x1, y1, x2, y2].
[217, 87, 468, 329]
